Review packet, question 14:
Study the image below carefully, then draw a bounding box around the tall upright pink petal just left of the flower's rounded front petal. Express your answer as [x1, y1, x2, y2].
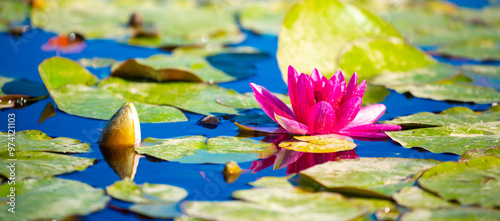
[294, 74, 315, 124]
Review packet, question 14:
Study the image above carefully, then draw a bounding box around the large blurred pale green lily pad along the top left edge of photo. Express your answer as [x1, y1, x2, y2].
[31, 0, 244, 46]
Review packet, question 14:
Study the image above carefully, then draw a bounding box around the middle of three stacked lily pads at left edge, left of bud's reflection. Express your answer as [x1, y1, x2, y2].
[0, 151, 95, 179]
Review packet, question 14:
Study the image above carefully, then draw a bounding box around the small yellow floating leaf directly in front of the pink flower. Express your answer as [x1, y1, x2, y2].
[279, 135, 357, 153]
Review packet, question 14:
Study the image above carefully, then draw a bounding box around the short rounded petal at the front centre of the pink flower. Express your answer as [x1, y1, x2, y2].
[307, 101, 336, 134]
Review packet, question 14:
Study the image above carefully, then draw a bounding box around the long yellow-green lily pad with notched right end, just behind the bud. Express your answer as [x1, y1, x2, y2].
[99, 78, 238, 115]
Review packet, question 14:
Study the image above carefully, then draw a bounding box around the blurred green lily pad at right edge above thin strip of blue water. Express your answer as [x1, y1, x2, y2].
[435, 40, 500, 61]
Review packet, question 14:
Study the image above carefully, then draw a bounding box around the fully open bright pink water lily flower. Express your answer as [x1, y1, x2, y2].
[250, 66, 401, 138]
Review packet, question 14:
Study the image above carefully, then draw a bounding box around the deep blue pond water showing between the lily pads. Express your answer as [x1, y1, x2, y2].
[0, 0, 500, 220]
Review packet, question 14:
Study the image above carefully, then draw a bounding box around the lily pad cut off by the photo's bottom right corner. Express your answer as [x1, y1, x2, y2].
[401, 207, 500, 221]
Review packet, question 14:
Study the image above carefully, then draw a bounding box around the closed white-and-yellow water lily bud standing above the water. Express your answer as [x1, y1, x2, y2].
[98, 103, 141, 147]
